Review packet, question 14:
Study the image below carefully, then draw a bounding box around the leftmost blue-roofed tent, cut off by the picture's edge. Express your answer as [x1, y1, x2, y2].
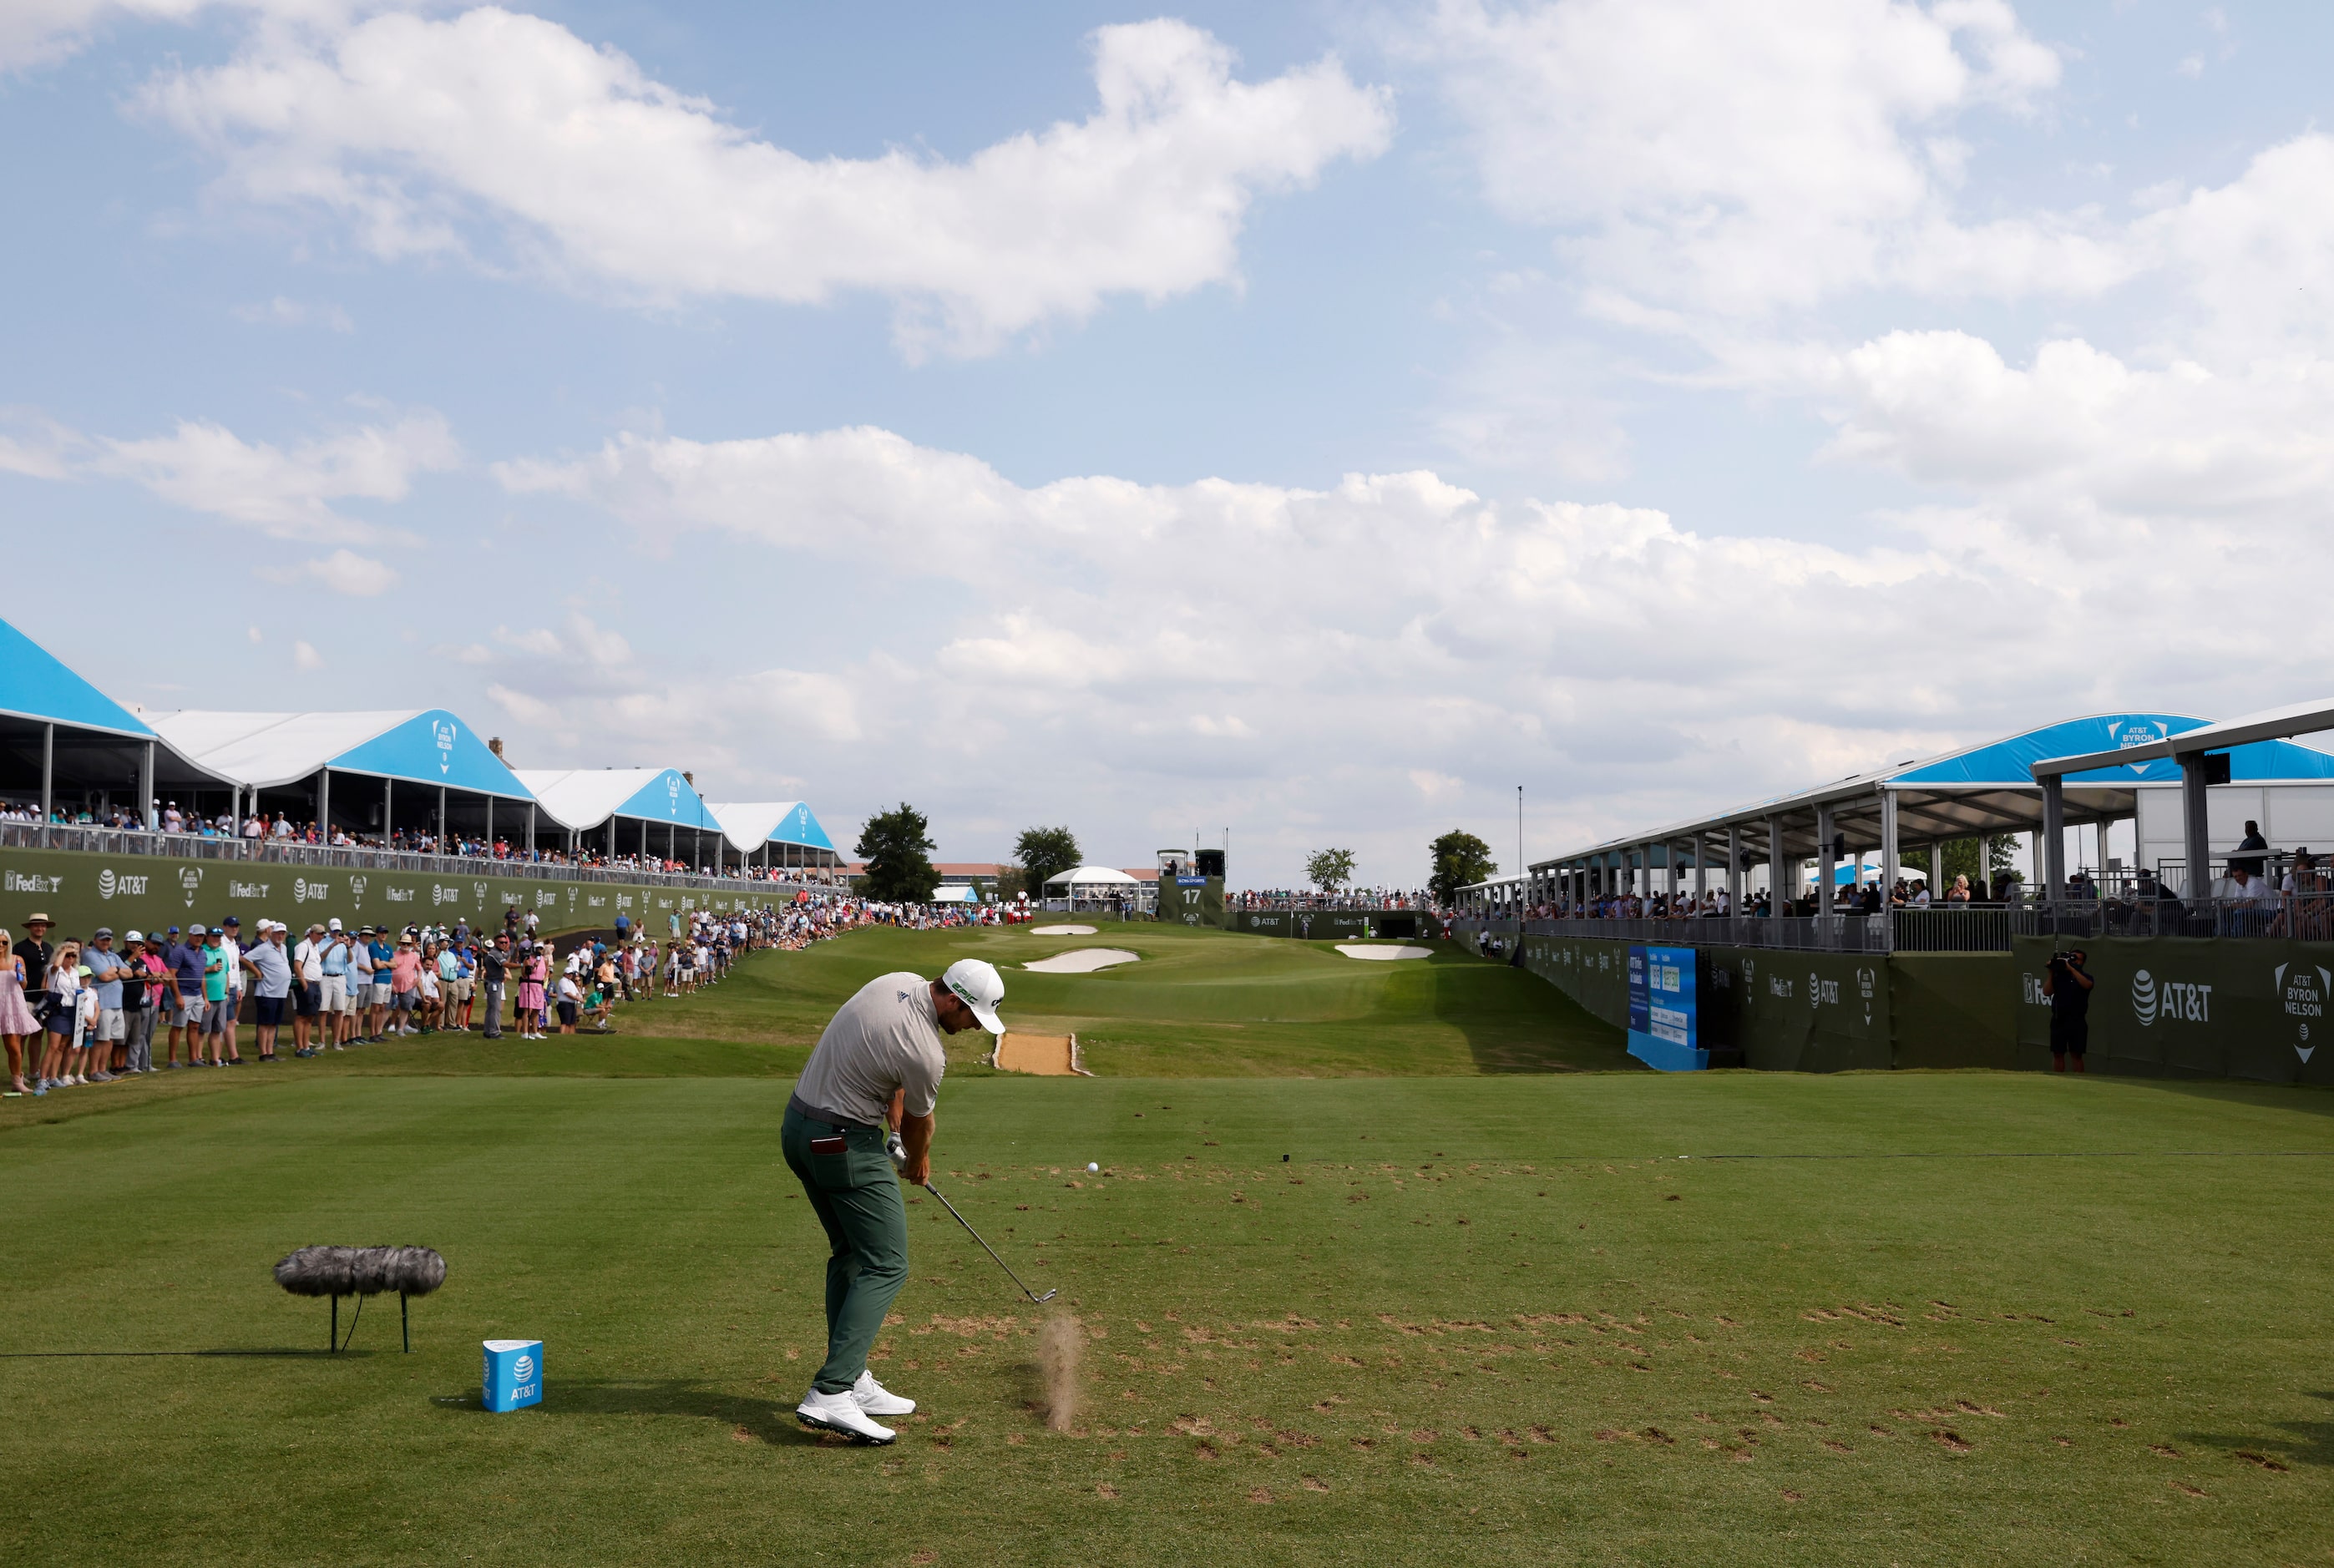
[0, 620, 196, 819]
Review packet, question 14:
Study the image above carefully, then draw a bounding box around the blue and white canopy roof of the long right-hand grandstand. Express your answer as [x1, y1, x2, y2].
[1532, 714, 2334, 873]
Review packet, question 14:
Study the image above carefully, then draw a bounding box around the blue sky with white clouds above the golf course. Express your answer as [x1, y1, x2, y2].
[0, 0, 2334, 882]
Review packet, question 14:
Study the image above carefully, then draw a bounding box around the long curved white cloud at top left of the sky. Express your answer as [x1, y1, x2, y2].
[144, 7, 1394, 352]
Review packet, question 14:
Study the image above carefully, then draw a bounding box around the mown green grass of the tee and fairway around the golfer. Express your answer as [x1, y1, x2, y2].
[0, 928, 2334, 1563]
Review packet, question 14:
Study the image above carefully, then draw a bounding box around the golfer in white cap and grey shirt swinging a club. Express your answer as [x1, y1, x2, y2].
[780, 959, 1006, 1442]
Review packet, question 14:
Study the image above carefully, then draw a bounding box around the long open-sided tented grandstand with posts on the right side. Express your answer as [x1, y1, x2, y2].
[1526, 714, 2334, 905]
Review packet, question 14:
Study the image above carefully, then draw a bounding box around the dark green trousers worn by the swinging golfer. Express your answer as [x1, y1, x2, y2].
[780, 1106, 908, 1393]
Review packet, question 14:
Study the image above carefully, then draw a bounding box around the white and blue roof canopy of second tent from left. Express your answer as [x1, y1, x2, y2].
[154, 707, 534, 801]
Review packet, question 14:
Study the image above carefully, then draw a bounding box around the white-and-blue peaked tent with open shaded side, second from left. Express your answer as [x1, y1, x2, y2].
[154, 707, 534, 847]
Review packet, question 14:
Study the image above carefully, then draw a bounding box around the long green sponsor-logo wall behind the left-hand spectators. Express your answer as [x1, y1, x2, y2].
[0, 849, 793, 938]
